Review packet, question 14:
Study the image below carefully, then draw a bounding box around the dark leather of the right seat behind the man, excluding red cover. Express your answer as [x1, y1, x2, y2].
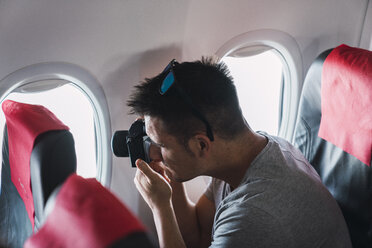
[293, 49, 372, 248]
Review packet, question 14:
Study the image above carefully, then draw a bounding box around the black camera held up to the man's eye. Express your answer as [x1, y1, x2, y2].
[111, 120, 151, 167]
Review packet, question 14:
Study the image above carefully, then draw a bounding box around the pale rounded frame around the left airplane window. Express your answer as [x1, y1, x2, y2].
[0, 62, 112, 187]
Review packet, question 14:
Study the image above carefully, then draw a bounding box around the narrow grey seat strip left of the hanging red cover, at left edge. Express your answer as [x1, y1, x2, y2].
[0, 126, 32, 248]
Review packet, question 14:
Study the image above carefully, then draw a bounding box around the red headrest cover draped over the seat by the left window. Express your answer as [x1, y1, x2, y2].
[2, 100, 69, 230]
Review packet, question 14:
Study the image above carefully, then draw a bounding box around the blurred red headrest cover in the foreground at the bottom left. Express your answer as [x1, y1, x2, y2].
[24, 174, 152, 248]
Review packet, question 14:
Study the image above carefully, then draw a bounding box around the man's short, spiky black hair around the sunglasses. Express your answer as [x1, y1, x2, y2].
[127, 57, 245, 142]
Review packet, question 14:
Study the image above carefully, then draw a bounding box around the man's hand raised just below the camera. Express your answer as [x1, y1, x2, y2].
[134, 159, 172, 210]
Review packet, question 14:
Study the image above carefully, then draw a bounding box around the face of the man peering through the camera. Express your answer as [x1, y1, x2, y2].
[145, 116, 200, 182]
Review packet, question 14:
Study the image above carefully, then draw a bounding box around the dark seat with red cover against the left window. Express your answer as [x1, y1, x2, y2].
[0, 100, 76, 247]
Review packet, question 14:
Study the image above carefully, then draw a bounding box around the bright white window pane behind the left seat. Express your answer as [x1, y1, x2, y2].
[1, 83, 97, 177]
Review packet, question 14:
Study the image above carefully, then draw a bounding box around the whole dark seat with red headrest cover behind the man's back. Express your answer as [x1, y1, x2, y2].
[293, 45, 372, 248]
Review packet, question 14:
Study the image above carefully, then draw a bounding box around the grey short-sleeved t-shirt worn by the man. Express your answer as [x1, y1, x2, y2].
[205, 133, 351, 248]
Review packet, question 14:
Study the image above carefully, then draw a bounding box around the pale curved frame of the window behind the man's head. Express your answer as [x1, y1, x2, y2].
[215, 29, 303, 141]
